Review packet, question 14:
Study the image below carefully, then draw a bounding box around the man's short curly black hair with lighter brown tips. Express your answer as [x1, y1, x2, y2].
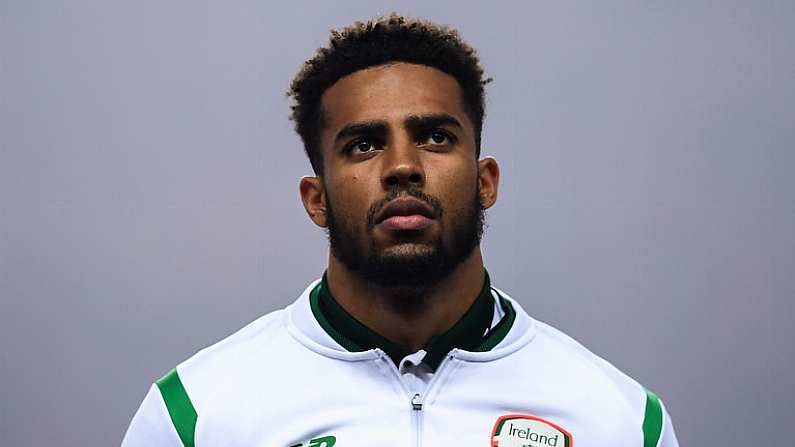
[287, 13, 491, 174]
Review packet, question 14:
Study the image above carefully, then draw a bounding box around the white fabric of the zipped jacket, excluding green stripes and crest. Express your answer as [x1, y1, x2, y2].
[122, 283, 678, 447]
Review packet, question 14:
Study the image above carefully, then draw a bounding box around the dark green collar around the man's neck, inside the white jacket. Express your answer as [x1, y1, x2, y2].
[309, 273, 516, 371]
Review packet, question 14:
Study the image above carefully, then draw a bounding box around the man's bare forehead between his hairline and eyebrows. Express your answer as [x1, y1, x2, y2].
[321, 63, 471, 134]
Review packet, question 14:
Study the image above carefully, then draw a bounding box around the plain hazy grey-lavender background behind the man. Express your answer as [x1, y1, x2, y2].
[0, 0, 795, 447]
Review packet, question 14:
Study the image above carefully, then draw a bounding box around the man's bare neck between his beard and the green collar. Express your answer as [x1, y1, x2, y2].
[327, 247, 485, 350]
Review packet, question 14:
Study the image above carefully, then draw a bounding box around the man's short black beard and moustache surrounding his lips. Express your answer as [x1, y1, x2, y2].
[326, 185, 485, 292]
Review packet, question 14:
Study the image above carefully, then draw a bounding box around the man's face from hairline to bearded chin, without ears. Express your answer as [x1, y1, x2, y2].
[314, 63, 483, 286]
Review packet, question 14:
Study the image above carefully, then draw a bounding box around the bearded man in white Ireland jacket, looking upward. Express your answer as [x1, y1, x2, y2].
[123, 15, 678, 447]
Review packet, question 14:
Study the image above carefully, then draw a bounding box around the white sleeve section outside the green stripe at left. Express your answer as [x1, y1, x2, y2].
[121, 385, 183, 447]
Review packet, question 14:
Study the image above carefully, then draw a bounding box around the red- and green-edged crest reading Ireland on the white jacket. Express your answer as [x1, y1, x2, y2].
[491, 414, 573, 447]
